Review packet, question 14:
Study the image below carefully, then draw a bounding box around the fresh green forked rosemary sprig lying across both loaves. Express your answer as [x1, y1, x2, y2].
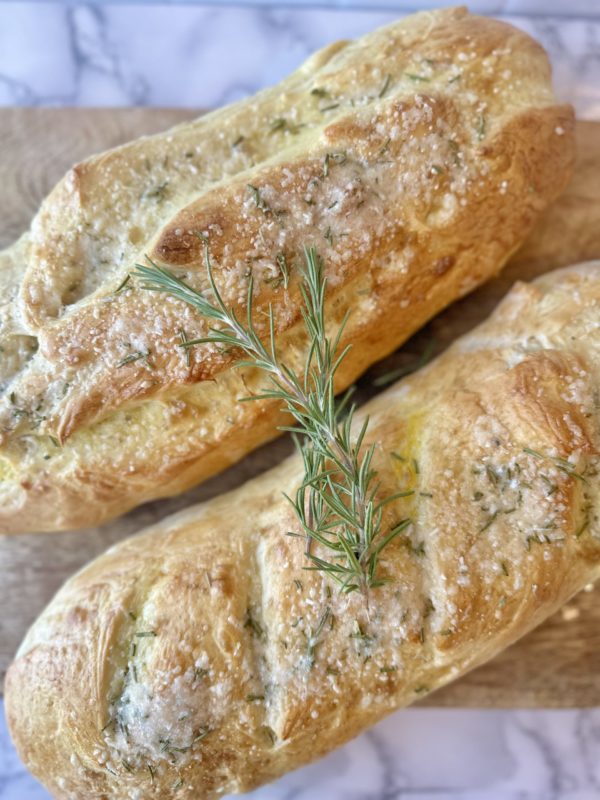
[136, 244, 404, 592]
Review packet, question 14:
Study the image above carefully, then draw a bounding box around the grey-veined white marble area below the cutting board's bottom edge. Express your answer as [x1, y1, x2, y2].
[0, 708, 600, 800]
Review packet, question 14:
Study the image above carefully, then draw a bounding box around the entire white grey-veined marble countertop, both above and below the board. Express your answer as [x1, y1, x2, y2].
[0, 0, 600, 800]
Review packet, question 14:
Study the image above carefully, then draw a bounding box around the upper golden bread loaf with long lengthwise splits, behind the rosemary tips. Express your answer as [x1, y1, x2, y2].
[0, 9, 573, 533]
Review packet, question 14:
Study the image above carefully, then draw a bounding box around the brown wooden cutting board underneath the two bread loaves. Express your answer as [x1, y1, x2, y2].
[0, 109, 600, 707]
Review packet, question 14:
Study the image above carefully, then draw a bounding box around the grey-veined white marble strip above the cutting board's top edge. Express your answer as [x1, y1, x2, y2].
[0, 0, 600, 119]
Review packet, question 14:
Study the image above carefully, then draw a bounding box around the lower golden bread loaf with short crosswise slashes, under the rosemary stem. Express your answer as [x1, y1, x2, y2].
[6, 262, 600, 800]
